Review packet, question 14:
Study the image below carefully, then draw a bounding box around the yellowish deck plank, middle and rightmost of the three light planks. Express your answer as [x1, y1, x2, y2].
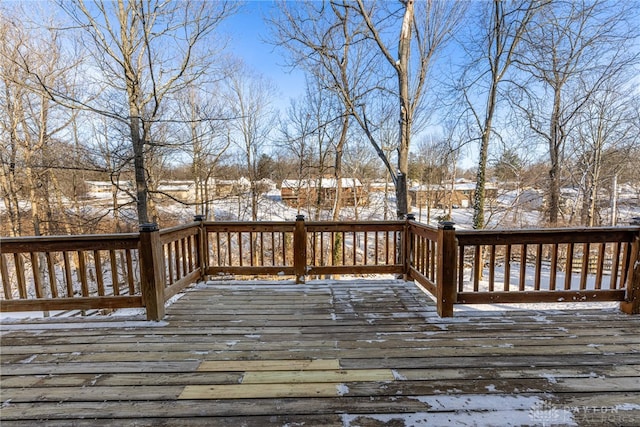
[242, 369, 395, 384]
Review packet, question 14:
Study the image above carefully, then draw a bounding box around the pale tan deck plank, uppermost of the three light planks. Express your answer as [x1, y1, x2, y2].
[198, 359, 340, 372]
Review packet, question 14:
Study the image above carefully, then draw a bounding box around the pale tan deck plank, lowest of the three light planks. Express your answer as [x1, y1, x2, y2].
[178, 383, 342, 400]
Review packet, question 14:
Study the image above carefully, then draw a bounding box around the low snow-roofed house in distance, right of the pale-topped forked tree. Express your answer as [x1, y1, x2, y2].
[409, 181, 498, 209]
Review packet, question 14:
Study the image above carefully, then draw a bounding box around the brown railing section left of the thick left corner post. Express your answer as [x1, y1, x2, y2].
[0, 234, 142, 311]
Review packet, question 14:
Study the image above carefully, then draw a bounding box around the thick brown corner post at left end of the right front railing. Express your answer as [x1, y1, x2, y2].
[436, 221, 457, 317]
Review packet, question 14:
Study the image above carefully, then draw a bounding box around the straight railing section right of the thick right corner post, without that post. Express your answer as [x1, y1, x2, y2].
[456, 228, 638, 303]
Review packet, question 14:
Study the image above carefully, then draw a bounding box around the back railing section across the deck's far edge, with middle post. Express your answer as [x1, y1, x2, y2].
[204, 216, 405, 283]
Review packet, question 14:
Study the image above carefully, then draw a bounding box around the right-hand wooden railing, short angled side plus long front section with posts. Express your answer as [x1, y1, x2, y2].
[407, 221, 640, 316]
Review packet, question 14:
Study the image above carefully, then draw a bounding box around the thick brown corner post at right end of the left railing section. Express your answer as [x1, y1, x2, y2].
[139, 224, 165, 320]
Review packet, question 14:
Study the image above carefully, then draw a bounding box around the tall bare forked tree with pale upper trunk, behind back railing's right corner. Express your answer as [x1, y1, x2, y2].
[275, 0, 465, 216]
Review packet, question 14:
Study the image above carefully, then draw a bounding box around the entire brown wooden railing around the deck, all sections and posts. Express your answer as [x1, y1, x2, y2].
[0, 216, 640, 320]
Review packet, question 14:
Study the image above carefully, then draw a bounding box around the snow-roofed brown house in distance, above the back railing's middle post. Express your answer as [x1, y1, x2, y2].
[280, 178, 368, 208]
